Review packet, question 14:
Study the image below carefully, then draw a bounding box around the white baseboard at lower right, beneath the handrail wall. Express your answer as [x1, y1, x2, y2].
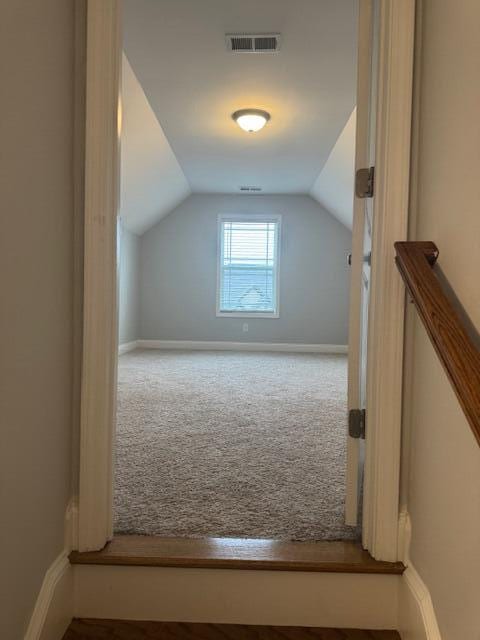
[398, 512, 442, 640]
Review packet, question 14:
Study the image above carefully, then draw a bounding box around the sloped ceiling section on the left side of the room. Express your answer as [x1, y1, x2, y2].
[120, 55, 190, 235]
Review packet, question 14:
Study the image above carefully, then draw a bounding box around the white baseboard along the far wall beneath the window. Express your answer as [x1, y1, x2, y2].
[137, 340, 348, 353]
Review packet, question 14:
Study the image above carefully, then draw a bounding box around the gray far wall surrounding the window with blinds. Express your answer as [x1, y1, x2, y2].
[140, 195, 351, 344]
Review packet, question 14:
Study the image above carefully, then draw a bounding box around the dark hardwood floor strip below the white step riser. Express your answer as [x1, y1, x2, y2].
[63, 619, 400, 640]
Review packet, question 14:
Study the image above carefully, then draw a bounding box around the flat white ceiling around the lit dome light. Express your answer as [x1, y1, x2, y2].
[124, 0, 357, 193]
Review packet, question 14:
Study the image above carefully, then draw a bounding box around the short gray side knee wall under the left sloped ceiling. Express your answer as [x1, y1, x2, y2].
[118, 227, 140, 344]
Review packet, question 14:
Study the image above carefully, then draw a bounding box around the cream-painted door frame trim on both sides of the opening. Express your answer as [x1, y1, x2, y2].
[78, 0, 415, 561]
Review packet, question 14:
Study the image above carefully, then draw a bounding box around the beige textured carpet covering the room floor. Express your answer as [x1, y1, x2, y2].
[115, 350, 359, 540]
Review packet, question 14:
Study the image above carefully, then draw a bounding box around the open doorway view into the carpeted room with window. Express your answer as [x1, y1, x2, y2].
[114, 0, 360, 540]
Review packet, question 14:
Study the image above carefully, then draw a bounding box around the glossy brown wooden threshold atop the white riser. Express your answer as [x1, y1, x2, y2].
[70, 535, 405, 575]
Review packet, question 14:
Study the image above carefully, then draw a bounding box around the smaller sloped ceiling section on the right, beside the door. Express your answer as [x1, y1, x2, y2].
[310, 109, 357, 229]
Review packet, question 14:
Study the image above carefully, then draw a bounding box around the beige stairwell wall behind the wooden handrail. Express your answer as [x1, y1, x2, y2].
[405, 0, 480, 640]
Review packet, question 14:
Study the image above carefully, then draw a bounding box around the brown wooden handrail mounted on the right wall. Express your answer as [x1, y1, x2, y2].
[395, 242, 480, 445]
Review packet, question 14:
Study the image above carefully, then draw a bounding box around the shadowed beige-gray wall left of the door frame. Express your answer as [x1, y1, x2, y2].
[0, 0, 74, 640]
